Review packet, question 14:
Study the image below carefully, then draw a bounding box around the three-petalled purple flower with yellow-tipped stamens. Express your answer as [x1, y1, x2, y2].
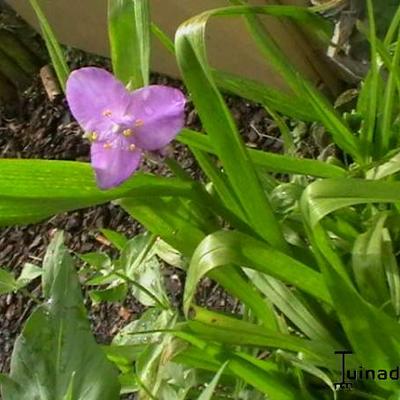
[66, 67, 186, 189]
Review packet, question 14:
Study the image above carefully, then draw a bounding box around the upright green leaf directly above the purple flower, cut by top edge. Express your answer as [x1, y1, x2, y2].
[108, 0, 151, 89]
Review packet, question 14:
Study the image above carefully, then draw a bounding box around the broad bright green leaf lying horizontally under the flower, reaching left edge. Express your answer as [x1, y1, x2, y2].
[0, 159, 196, 226]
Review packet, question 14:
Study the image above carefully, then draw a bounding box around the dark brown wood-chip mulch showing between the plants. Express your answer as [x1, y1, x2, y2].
[0, 51, 282, 372]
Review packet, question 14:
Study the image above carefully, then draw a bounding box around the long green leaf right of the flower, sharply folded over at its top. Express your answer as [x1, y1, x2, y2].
[175, 7, 288, 251]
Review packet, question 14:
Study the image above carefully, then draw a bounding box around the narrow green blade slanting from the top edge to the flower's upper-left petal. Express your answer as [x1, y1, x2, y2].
[29, 0, 70, 90]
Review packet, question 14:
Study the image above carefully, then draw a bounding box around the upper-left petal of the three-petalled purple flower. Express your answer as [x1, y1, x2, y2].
[66, 67, 130, 133]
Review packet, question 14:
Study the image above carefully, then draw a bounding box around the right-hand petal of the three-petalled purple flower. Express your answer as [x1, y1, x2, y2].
[128, 85, 186, 150]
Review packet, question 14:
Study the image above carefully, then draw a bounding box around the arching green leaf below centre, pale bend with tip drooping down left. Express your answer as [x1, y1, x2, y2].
[184, 231, 331, 313]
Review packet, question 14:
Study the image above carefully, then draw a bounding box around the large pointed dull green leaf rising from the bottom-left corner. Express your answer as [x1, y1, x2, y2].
[2, 233, 120, 400]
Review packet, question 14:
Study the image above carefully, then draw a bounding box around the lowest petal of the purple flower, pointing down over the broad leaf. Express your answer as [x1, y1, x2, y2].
[91, 143, 142, 189]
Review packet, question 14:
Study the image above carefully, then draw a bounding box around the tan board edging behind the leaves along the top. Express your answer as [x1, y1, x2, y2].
[6, 0, 336, 90]
